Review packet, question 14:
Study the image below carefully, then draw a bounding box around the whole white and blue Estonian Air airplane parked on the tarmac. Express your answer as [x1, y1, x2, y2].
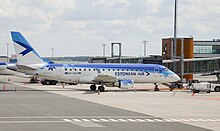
[11, 31, 180, 92]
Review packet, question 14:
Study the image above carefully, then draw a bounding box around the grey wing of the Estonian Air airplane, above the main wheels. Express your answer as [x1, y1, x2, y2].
[93, 73, 118, 82]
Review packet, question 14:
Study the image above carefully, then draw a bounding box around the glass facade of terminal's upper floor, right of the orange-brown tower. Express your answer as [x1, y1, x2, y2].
[194, 45, 220, 54]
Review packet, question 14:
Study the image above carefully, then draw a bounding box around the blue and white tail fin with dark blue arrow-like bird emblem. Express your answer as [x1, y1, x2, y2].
[11, 31, 45, 66]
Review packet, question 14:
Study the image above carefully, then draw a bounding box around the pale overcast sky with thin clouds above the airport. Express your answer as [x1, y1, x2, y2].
[0, 0, 220, 56]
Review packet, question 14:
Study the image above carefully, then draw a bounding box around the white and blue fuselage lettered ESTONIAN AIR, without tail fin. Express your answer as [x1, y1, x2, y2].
[19, 64, 179, 84]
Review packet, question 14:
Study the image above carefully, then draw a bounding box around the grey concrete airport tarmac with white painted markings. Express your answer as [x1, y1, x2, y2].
[0, 76, 220, 131]
